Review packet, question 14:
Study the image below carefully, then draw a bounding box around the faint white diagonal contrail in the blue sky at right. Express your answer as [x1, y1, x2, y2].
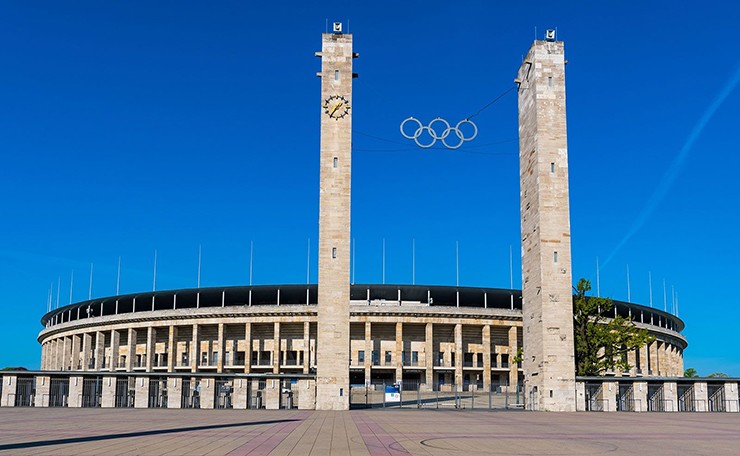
[604, 65, 740, 266]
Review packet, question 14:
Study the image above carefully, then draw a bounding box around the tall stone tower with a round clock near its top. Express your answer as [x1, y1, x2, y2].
[316, 23, 357, 410]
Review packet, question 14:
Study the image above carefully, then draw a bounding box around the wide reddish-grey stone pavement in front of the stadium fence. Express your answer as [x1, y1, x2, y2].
[0, 408, 740, 456]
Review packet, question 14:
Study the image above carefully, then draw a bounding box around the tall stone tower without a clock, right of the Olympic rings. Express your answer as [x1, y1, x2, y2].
[516, 37, 575, 411]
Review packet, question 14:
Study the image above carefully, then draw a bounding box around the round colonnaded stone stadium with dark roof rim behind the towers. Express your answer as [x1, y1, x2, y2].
[28, 284, 687, 408]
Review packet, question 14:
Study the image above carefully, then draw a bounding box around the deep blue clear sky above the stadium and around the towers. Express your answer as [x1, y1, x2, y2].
[0, 1, 740, 376]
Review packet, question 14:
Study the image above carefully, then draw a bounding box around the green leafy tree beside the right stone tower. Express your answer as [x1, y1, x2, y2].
[573, 279, 655, 376]
